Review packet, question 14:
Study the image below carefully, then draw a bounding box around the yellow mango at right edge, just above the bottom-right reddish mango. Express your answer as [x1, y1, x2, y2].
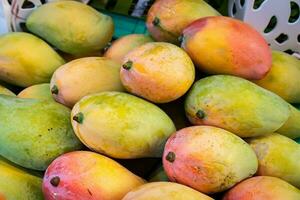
[247, 133, 300, 188]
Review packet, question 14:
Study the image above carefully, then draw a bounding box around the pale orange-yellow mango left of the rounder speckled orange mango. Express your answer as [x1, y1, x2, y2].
[50, 57, 124, 108]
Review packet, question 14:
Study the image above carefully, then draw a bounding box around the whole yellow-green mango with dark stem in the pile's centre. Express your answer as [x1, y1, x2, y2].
[71, 92, 175, 159]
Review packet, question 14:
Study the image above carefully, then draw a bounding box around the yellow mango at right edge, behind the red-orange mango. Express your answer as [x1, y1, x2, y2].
[254, 51, 300, 103]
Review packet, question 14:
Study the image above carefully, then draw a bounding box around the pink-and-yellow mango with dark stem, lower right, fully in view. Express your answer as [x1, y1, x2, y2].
[163, 126, 258, 194]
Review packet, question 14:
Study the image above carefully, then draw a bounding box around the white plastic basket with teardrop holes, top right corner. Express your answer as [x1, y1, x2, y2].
[228, 0, 300, 56]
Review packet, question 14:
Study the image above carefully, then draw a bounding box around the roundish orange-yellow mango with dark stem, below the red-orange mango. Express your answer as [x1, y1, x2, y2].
[120, 42, 195, 103]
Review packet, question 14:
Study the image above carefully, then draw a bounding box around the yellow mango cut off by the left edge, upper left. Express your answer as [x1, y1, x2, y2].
[0, 32, 64, 87]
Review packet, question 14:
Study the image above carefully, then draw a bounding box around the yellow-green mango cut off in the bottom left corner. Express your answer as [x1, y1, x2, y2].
[0, 157, 44, 200]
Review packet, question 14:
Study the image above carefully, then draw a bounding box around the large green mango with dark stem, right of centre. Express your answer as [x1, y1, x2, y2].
[185, 75, 290, 137]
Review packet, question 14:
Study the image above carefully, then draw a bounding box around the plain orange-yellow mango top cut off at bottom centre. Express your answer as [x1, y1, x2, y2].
[122, 182, 213, 200]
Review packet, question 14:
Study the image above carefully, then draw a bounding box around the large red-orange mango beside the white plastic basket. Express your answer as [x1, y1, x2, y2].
[181, 16, 272, 80]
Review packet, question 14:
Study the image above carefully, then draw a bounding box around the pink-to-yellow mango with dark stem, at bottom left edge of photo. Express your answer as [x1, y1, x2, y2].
[43, 151, 145, 200]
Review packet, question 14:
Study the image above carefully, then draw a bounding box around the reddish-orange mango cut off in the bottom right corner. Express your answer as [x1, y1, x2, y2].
[223, 176, 300, 200]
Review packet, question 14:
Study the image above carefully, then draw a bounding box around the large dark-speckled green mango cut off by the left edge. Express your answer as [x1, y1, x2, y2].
[0, 95, 82, 170]
